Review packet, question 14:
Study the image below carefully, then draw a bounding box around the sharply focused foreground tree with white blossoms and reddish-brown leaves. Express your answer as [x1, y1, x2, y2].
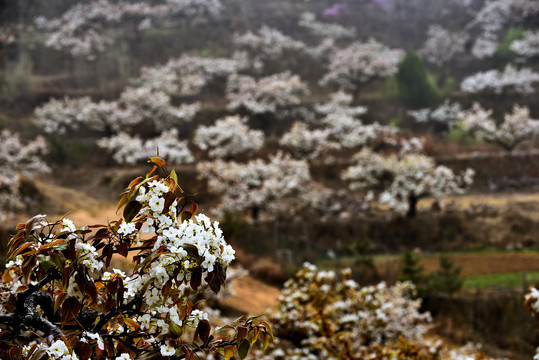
[0, 157, 272, 360]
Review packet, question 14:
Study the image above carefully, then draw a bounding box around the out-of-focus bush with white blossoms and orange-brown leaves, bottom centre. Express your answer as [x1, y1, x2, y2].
[272, 263, 438, 359]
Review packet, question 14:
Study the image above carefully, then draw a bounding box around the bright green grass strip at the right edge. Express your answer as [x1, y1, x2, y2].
[463, 271, 539, 290]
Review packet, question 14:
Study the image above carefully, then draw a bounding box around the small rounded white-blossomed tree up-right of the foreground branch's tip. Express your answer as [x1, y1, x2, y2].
[193, 115, 264, 158]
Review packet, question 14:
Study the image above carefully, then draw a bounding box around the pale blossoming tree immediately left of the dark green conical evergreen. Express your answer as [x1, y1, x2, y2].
[320, 39, 404, 90]
